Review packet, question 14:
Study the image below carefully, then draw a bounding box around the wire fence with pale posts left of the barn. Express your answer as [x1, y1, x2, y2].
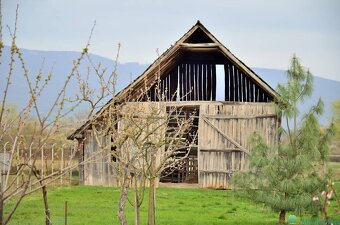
[0, 144, 80, 189]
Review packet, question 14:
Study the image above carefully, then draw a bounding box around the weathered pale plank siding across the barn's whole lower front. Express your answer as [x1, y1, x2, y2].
[84, 101, 279, 189]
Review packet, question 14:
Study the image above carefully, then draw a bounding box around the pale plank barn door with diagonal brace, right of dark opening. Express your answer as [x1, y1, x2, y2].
[198, 103, 276, 189]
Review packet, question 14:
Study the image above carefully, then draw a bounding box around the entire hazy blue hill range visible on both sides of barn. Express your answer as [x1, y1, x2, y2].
[0, 46, 340, 125]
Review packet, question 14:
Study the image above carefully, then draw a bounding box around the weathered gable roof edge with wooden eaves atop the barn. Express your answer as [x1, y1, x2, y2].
[68, 21, 278, 139]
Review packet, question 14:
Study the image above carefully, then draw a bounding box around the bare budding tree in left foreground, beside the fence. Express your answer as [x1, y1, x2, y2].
[0, 1, 97, 224]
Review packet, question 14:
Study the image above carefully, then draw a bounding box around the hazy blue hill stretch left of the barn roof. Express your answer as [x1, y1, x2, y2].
[0, 46, 147, 115]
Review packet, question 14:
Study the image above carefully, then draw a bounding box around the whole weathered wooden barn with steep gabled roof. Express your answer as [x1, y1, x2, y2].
[69, 21, 280, 189]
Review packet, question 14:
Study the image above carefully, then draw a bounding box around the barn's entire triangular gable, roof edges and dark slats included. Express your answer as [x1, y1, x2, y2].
[117, 21, 277, 102]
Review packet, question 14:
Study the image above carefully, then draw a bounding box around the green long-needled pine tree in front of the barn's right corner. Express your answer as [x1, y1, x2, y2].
[233, 55, 333, 223]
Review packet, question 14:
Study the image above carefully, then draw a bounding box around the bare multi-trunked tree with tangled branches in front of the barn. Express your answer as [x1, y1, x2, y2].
[77, 48, 195, 224]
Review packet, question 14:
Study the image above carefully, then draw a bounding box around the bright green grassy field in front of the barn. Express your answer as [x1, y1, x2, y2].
[4, 185, 340, 225]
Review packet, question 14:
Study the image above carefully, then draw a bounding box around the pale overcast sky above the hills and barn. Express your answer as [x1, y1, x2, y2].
[2, 0, 340, 80]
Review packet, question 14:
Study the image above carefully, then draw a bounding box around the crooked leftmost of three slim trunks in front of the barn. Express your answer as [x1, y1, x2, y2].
[118, 165, 130, 225]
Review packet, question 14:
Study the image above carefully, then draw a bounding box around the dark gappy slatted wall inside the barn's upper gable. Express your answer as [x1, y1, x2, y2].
[143, 52, 273, 102]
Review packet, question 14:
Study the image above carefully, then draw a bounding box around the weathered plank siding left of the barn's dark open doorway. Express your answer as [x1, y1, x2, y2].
[84, 102, 166, 187]
